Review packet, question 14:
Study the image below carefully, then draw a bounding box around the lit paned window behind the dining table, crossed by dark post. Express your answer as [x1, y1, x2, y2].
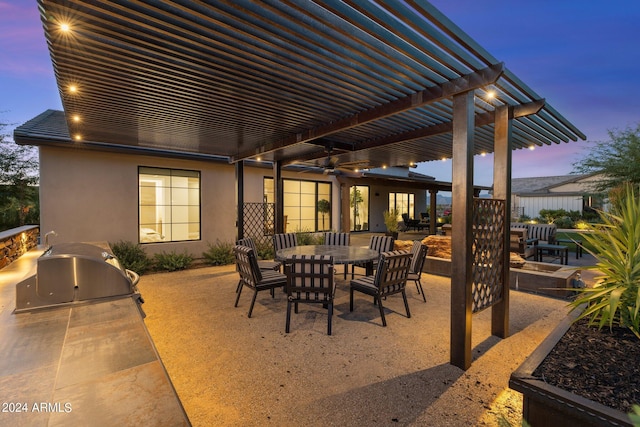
[263, 178, 331, 232]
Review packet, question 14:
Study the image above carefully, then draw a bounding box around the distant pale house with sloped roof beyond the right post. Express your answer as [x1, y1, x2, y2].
[511, 174, 604, 218]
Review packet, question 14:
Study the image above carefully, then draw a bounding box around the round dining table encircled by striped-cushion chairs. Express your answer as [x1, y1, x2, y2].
[276, 245, 380, 275]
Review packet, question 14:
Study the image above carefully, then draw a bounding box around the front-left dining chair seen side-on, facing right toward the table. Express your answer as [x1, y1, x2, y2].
[233, 245, 287, 317]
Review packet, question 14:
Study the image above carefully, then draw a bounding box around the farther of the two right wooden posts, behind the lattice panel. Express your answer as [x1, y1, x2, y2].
[491, 106, 511, 338]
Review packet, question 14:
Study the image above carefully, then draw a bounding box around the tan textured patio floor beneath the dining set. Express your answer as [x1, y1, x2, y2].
[0, 237, 590, 426]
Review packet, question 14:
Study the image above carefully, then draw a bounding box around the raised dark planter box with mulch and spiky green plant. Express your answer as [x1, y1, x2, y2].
[509, 186, 640, 427]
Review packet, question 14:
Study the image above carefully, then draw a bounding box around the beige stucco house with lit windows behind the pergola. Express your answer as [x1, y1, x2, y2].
[14, 110, 442, 255]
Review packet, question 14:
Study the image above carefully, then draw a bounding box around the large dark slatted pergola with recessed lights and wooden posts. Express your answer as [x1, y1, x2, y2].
[32, 0, 585, 369]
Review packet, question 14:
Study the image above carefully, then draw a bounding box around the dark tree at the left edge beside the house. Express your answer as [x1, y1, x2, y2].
[0, 123, 39, 229]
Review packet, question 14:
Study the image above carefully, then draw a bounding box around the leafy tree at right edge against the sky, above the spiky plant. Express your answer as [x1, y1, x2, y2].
[573, 123, 640, 192]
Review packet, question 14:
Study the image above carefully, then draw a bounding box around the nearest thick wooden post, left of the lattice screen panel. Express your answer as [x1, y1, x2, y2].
[450, 91, 474, 370]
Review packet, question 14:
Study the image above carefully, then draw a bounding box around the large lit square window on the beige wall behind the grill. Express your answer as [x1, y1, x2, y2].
[138, 166, 200, 243]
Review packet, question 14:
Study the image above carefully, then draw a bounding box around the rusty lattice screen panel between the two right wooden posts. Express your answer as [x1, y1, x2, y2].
[472, 198, 506, 313]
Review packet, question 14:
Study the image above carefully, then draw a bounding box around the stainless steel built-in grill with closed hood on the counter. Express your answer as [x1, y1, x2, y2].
[16, 243, 143, 312]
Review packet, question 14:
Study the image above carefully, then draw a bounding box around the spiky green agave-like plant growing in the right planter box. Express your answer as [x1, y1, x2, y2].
[570, 185, 640, 338]
